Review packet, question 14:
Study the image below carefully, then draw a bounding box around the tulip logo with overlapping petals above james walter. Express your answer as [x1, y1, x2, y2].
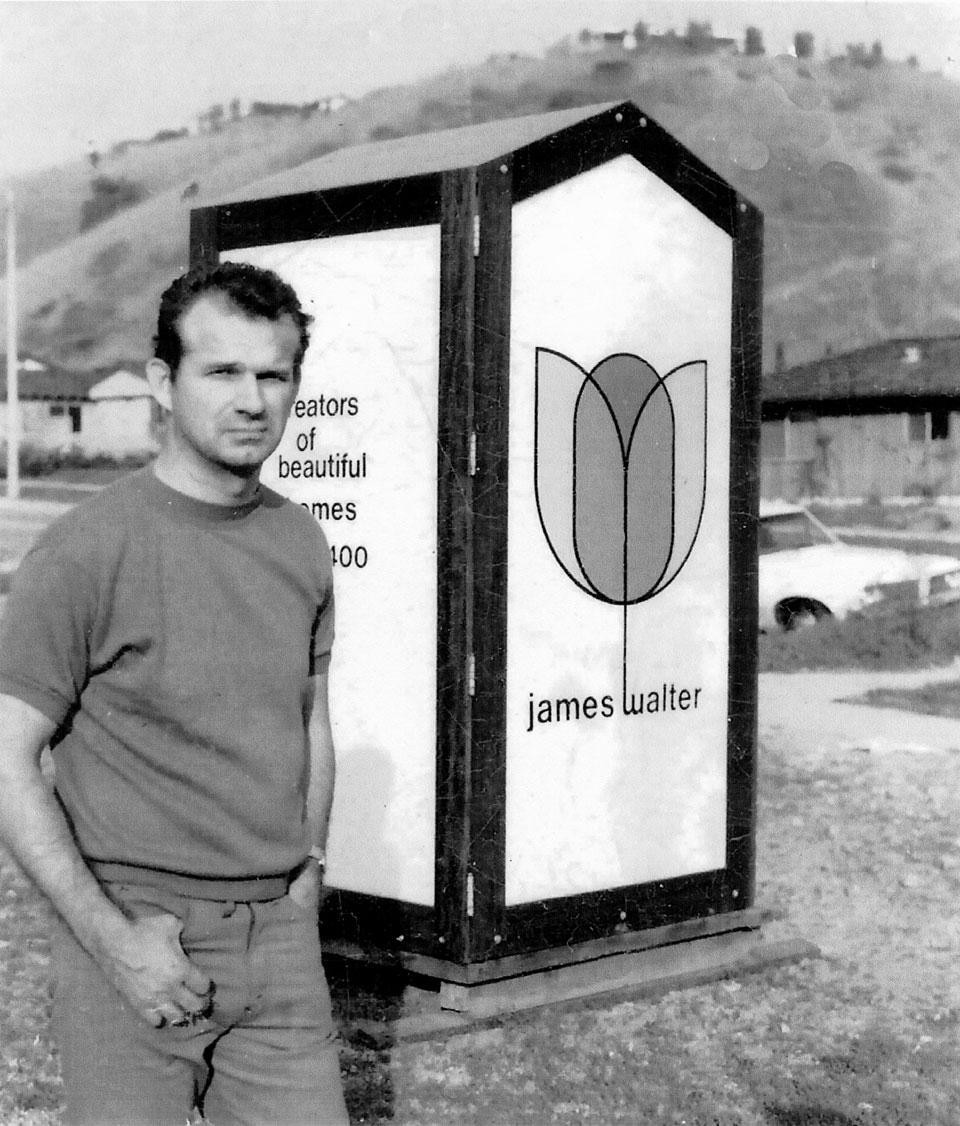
[533, 348, 707, 702]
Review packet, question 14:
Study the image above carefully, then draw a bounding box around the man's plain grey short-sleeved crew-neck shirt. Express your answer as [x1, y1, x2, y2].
[0, 468, 333, 878]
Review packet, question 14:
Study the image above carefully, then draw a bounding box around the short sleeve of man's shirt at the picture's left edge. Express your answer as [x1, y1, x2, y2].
[0, 526, 97, 726]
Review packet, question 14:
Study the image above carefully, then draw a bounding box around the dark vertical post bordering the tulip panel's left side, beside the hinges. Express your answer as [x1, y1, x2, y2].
[466, 159, 512, 962]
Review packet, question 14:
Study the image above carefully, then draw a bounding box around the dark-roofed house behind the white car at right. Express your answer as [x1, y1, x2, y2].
[761, 337, 960, 499]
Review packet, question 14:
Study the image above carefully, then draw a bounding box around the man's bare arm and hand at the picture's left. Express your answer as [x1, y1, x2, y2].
[0, 695, 210, 1025]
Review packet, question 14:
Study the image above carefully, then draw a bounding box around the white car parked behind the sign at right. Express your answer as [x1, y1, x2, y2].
[759, 501, 960, 631]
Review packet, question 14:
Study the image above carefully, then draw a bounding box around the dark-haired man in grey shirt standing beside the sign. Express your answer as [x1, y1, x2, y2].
[0, 263, 347, 1126]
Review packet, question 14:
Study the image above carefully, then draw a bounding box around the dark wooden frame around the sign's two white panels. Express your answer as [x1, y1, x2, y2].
[191, 102, 762, 981]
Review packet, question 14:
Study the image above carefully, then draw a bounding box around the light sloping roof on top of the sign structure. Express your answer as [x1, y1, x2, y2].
[212, 101, 618, 203]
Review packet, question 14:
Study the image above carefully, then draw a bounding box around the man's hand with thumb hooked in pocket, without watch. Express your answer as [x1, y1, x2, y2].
[102, 914, 213, 1028]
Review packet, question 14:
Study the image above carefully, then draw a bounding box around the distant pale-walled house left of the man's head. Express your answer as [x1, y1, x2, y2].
[0, 357, 158, 457]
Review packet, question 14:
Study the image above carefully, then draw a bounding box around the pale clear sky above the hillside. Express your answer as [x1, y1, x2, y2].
[0, 0, 960, 177]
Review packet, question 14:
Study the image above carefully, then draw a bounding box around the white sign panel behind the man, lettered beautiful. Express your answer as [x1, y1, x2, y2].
[224, 226, 440, 905]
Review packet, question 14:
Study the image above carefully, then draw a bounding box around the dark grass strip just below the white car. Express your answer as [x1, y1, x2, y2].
[760, 606, 960, 672]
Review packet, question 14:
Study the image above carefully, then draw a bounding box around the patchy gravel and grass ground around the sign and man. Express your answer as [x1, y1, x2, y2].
[0, 677, 960, 1126]
